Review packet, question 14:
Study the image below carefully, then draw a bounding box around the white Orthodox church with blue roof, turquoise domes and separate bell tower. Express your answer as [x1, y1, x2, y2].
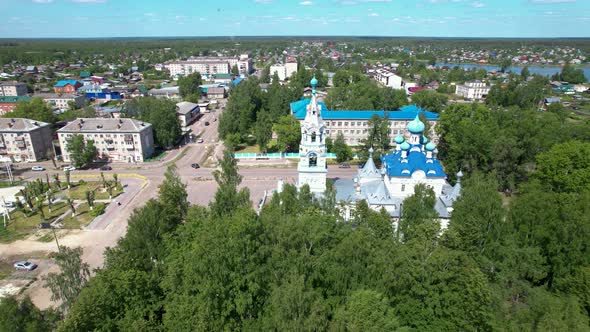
[297, 78, 463, 229]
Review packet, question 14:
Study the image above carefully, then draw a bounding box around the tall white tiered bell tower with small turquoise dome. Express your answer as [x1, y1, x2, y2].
[297, 77, 328, 194]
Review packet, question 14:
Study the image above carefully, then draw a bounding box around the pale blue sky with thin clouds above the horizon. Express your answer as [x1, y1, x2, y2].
[0, 0, 590, 38]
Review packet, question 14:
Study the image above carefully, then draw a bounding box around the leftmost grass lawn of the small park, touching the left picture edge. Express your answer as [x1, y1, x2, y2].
[0, 202, 68, 243]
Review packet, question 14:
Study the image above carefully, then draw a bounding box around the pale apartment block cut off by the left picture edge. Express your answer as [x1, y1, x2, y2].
[0, 118, 53, 162]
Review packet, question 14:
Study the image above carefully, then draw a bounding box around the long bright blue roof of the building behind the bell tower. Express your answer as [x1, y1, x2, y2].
[290, 99, 438, 120]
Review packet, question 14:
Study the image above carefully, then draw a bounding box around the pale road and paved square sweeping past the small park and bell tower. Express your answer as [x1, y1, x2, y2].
[0, 104, 356, 309]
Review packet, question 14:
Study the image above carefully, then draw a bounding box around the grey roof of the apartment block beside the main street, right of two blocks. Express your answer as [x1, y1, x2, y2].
[58, 118, 151, 133]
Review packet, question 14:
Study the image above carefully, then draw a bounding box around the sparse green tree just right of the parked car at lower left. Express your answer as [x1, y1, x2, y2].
[43, 246, 90, 312]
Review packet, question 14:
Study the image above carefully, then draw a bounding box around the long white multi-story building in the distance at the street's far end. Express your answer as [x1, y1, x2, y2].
[165, 57, 252, 77]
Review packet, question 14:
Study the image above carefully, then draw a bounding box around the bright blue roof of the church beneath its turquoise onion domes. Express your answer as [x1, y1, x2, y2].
[381, 148, 447, 178]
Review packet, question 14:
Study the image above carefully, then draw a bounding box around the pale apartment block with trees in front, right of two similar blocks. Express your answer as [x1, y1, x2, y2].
[57, 118, 154, 162]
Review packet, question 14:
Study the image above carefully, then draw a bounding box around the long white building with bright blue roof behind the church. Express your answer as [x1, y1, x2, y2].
[290, 99, 438, 145]
